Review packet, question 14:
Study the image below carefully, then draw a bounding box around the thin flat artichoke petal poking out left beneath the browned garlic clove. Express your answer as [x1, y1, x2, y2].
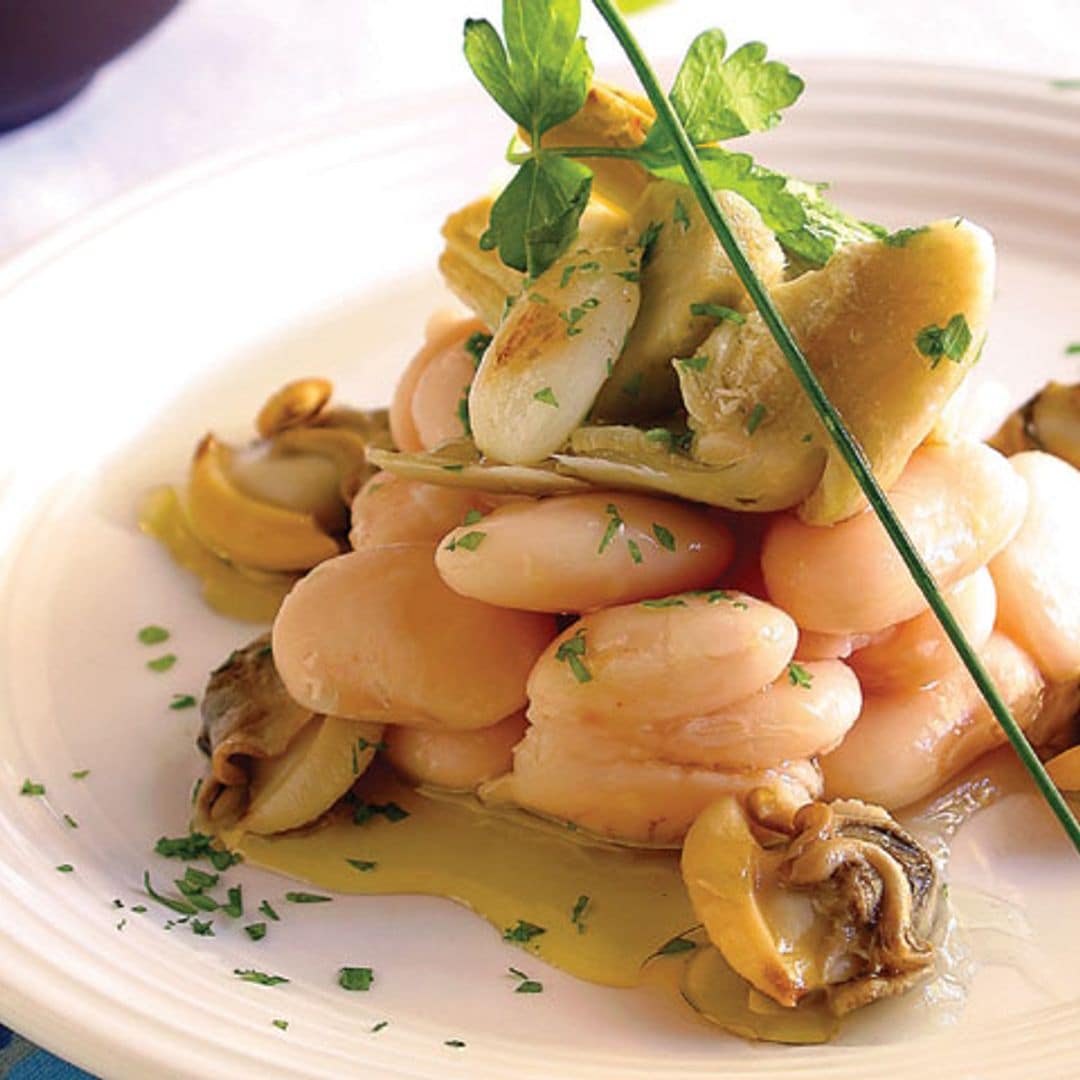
[367, 438, 589, 495]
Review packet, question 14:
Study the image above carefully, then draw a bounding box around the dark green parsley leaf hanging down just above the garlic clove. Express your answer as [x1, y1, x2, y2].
[481, 156, 593, 278]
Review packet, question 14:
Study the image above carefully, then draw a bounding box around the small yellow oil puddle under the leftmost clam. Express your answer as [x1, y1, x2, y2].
[138, 487, 296, 622]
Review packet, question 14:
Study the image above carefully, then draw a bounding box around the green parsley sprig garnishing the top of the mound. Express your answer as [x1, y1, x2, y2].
[464, 0, 885, 278]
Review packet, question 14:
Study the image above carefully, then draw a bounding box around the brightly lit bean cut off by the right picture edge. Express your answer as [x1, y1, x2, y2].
[990, 450, 1080, 681]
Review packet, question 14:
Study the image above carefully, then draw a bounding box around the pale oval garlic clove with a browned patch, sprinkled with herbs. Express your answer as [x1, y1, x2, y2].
[469, 245, 640, 464]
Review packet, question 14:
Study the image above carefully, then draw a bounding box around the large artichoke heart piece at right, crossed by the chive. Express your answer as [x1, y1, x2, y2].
[675, 220, 995, 525]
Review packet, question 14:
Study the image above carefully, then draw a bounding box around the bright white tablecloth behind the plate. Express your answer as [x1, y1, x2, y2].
[0, 0, 1080, 257]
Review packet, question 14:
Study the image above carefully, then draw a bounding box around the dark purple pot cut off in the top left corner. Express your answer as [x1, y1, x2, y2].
[0, 0, 179, 132]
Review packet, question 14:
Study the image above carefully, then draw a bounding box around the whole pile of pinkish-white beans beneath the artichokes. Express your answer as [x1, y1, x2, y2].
[273, 322, 1080, 843]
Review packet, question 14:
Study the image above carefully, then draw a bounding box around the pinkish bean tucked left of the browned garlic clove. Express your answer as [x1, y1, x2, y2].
[390, 319, 486, 454]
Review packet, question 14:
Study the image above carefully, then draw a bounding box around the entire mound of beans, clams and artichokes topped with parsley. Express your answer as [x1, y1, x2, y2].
[143, 0, 1080, 1041]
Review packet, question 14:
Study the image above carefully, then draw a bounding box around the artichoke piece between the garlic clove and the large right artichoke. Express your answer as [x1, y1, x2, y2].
[594, 180, 784, 420]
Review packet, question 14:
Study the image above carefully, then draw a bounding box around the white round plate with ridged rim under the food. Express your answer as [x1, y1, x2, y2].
[0, 62, 1080, 1080]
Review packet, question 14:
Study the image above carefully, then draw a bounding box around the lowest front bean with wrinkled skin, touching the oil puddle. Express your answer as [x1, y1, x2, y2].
[481, 725, 821, 845]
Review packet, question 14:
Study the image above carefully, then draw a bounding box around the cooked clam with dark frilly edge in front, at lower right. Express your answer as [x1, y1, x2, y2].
[681, 796, 940, 1015]
